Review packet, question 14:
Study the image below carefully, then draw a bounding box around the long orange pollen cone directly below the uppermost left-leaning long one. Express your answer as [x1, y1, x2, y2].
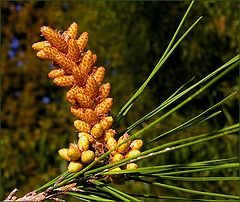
[43, 47, 77, 73]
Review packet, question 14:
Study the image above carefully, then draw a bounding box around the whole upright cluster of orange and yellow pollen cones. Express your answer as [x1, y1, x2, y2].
[32, 22, 143, 176]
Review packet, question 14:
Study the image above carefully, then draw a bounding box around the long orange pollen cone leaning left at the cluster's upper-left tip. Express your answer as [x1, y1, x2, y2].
[40, 26, 68, 53]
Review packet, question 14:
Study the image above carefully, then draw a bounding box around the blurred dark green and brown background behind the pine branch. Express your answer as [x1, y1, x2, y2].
[0, 1, 239, 200]
